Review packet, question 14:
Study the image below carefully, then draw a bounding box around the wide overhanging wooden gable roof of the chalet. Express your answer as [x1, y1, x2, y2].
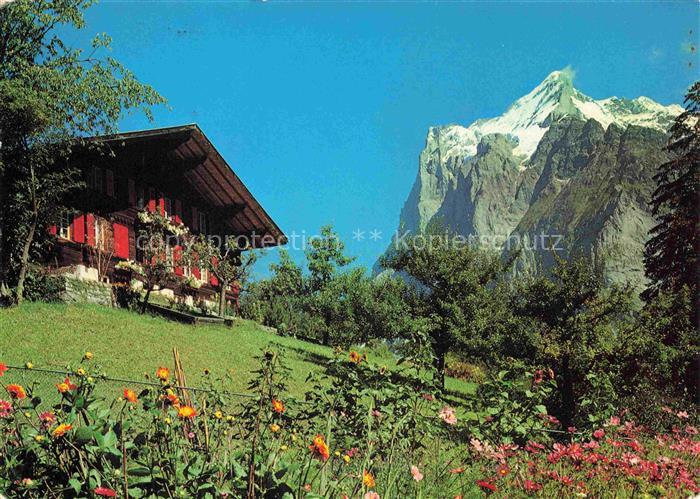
[93, 124, 287, 247]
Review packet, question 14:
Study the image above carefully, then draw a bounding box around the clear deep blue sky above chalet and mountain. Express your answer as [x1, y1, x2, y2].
[65, 0, 699, 273]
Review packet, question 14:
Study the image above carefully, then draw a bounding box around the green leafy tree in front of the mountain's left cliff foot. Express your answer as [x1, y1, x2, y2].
[382, 224, 508, 386]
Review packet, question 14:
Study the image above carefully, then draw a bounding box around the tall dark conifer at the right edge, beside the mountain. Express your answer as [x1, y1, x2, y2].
[643, 81, 700, 312]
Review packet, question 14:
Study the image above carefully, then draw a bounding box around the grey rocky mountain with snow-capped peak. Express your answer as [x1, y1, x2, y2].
[380, 70, 682, 287]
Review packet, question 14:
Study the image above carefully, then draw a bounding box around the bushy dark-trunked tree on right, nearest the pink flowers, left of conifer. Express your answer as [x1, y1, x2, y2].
[513, 259, 631, 428]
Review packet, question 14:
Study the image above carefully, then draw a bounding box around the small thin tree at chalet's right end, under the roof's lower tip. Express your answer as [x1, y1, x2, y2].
[186, 235, 257, 317]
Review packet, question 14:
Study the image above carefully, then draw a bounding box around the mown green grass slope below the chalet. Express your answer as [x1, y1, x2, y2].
[0, 303, 473, 404]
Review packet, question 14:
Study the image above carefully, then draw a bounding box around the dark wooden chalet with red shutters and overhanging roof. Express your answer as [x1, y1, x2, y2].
[50, 124, 286, 301]
